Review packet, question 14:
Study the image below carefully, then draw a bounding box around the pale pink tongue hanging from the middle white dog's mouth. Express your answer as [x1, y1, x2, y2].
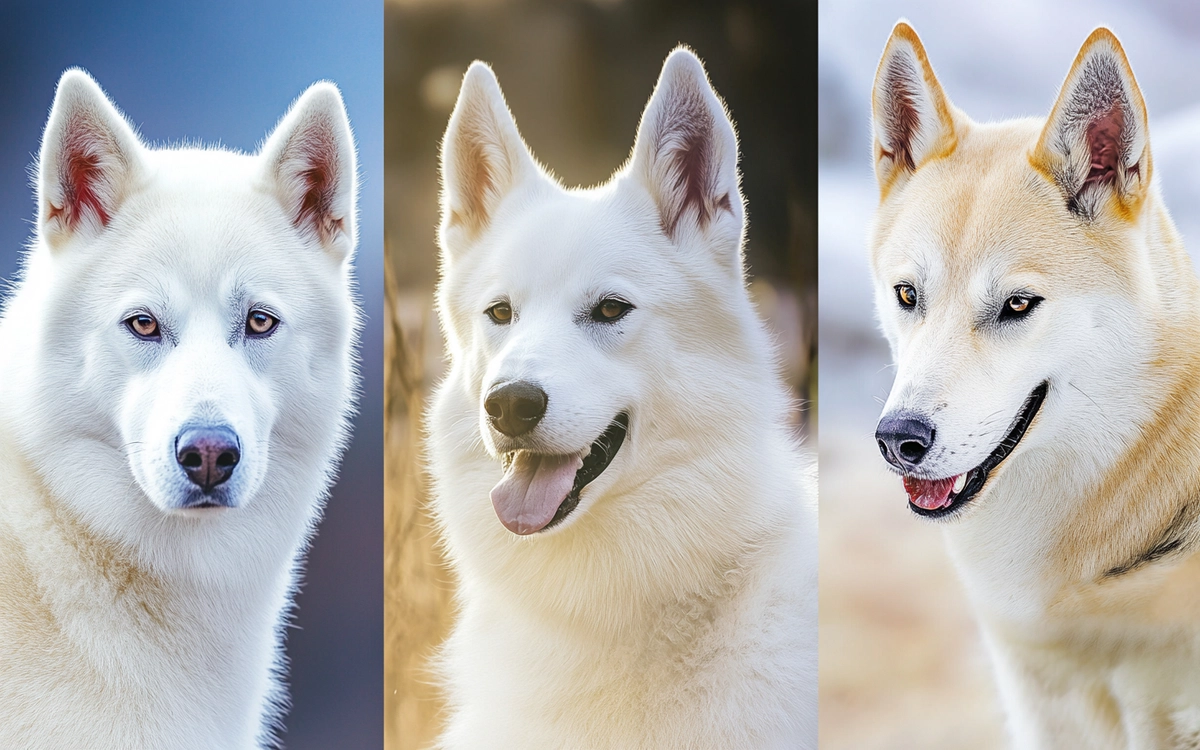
[492, 450, 583, 535]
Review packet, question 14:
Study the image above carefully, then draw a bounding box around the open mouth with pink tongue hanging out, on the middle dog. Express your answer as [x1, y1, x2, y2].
[492, 412, 629, 536]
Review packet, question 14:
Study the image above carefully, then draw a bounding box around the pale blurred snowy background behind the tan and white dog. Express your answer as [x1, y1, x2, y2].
[817, 0, 1200, 749]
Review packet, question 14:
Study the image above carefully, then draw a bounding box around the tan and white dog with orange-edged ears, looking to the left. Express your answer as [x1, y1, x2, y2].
[871, 22, 1200, 750]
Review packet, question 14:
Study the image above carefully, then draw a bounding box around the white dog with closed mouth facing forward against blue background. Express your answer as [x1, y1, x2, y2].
[0, 70, 359, 750]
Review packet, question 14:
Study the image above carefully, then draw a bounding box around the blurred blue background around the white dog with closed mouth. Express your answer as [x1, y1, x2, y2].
[0, 0, 383, 750]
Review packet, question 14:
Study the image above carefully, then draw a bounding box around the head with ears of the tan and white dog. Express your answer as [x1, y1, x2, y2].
[871, 22, 1166, 517]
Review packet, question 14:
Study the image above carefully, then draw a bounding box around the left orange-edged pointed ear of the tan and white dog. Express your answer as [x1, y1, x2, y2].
[871, 20, 958, 194]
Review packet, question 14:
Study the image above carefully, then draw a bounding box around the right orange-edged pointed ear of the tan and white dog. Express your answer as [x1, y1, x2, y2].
[1031, 28, 1151, 220]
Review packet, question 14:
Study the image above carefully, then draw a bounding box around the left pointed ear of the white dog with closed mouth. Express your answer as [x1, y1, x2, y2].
[37, 68, 142, 247]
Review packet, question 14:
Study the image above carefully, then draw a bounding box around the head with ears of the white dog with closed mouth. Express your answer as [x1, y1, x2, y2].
[6, 71, 358, 556]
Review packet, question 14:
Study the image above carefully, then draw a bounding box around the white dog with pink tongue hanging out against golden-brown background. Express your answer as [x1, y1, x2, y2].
[430, 49, 816, 749]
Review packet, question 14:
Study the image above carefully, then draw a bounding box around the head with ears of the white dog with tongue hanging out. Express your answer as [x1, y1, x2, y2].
[438, 49, 772, 535]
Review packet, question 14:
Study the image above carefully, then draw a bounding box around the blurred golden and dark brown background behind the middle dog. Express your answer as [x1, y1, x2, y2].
[384, 0, 817, 750]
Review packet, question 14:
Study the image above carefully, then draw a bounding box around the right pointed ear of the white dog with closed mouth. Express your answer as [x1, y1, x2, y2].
[260, 82, 358, 259]
